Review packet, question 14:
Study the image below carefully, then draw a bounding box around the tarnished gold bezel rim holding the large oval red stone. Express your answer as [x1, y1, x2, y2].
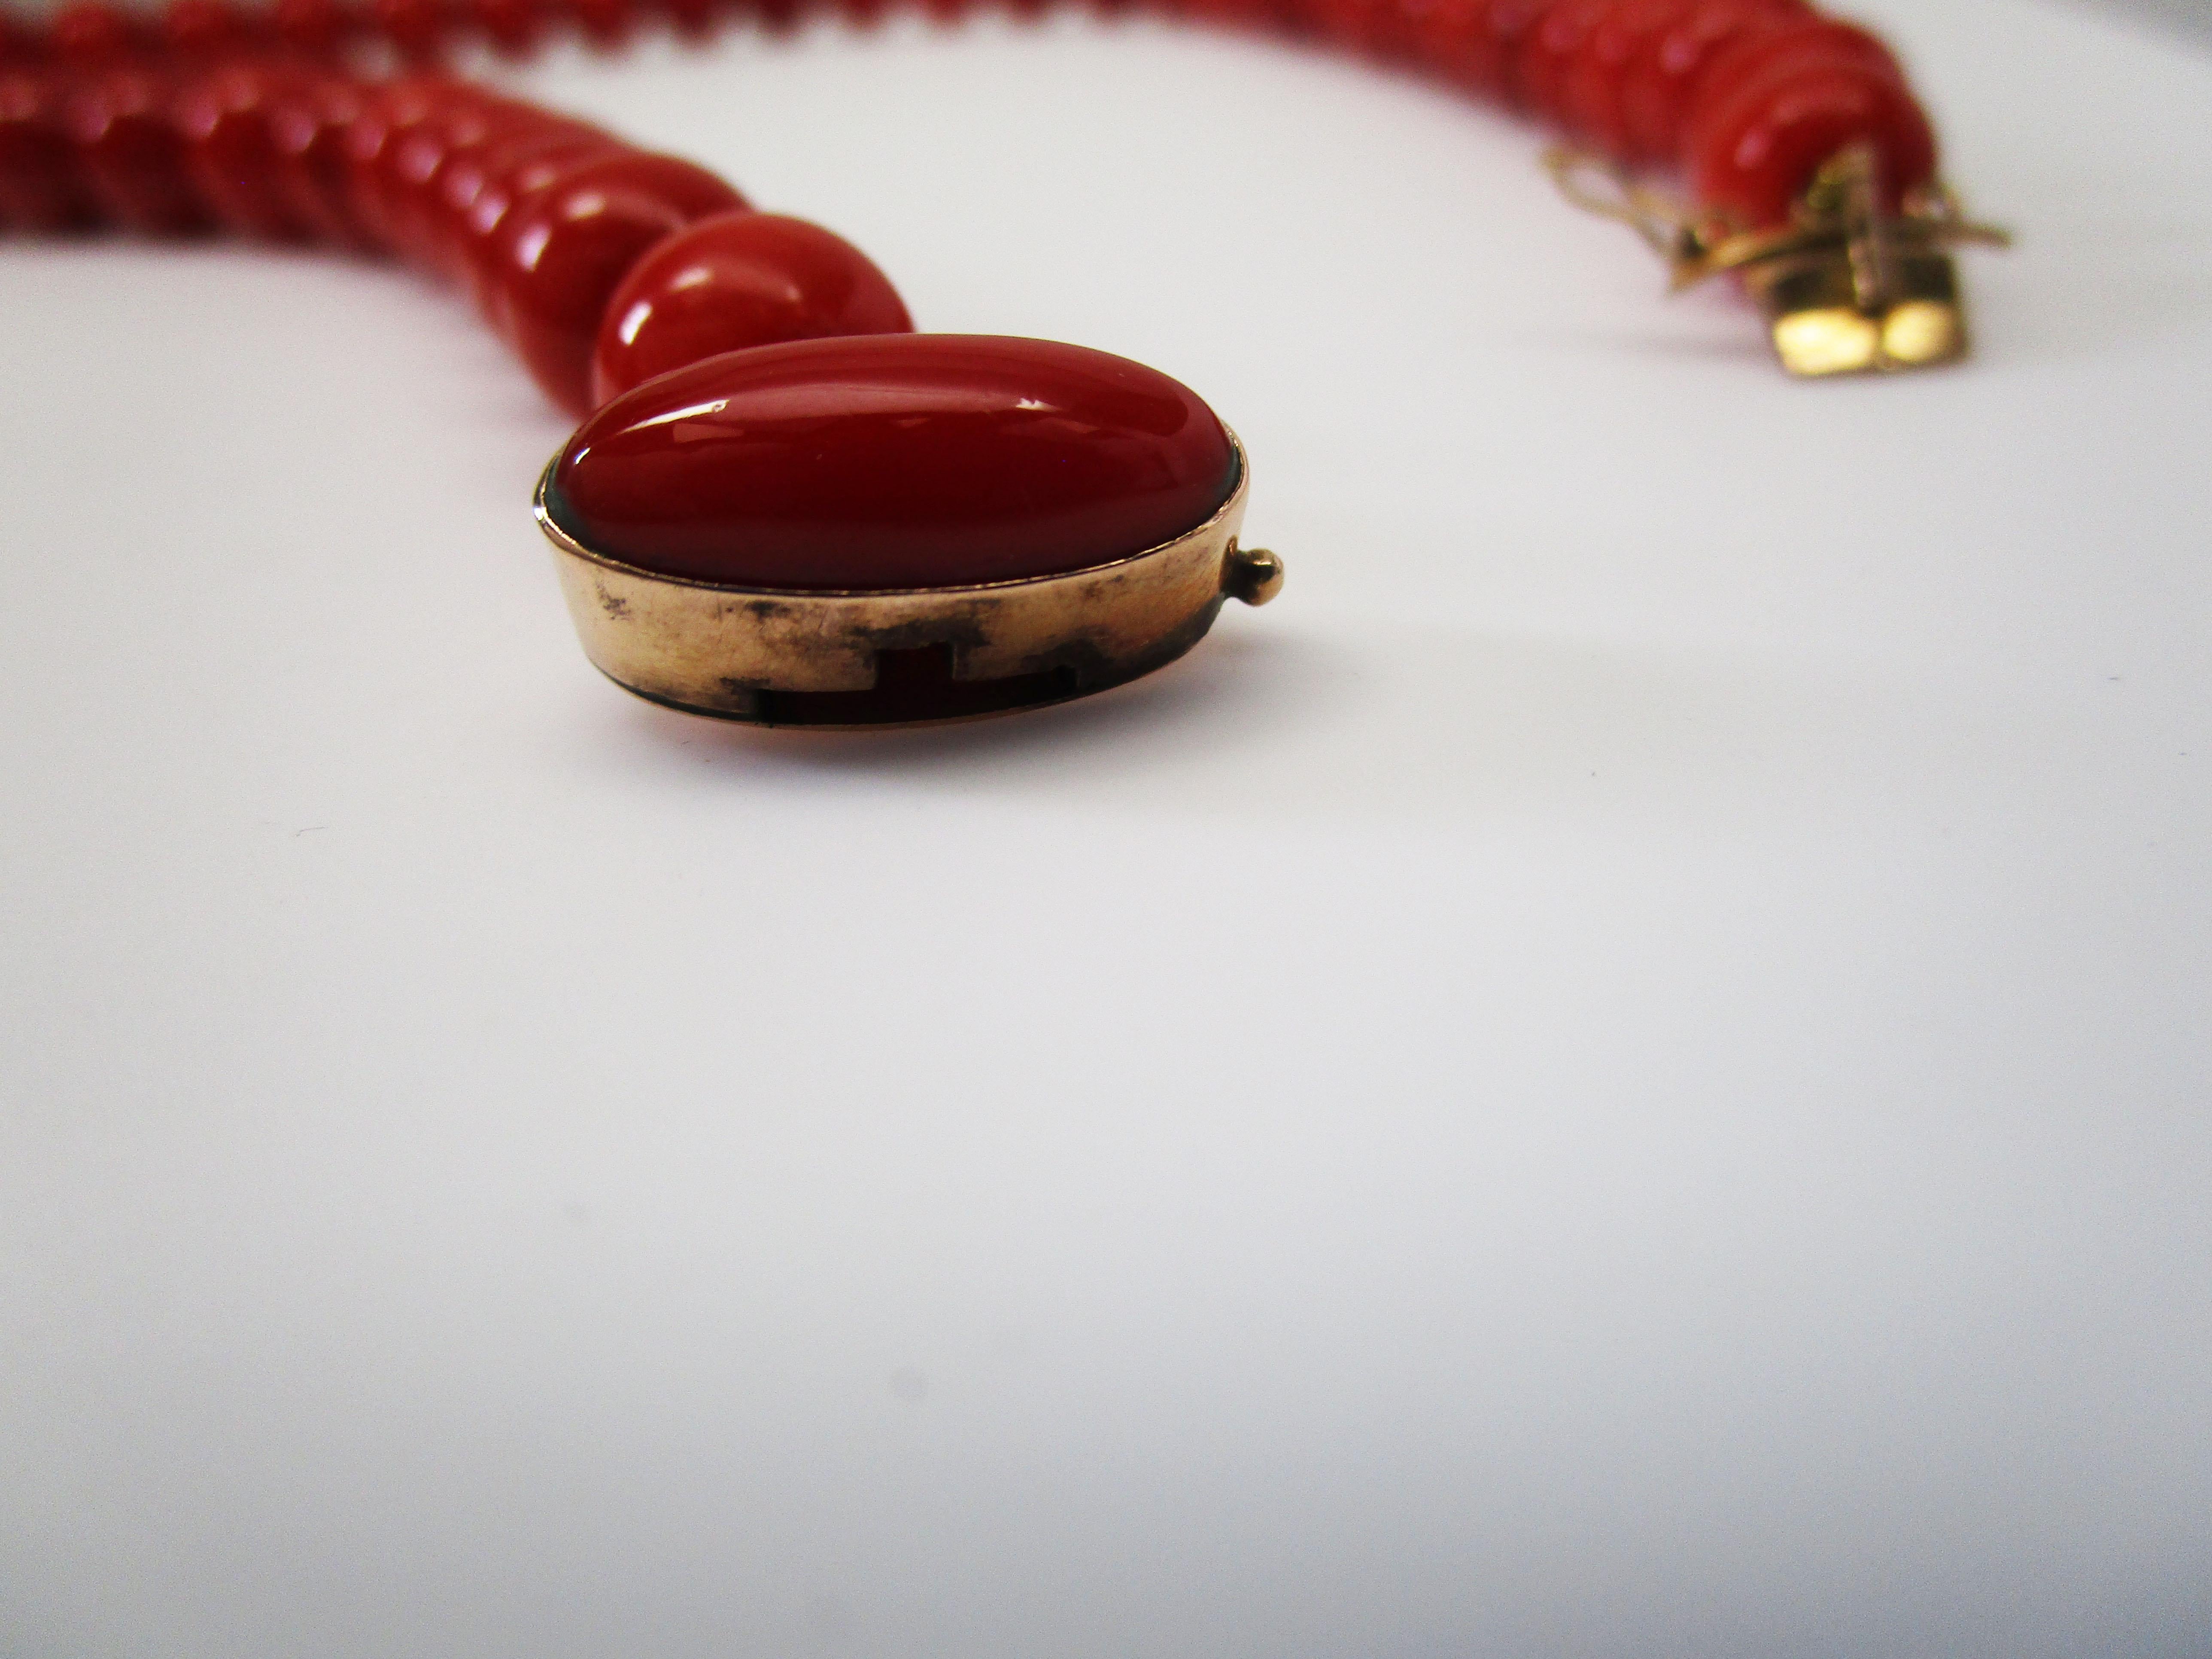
[533, 434, 1283, 728]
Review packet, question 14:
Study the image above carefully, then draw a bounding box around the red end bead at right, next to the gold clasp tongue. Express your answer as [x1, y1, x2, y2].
[1690, 62, 1936, 226]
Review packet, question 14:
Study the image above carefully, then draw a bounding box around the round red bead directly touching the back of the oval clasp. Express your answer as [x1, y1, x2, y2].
[591, 213, 914, 403]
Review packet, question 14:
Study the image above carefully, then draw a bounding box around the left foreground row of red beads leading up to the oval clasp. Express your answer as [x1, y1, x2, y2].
[0, 49, 914, 413]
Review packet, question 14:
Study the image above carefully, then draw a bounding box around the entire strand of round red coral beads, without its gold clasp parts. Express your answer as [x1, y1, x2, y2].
[0, 0, 1936, 413]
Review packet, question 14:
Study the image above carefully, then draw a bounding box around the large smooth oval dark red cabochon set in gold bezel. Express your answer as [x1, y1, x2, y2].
[549, 334, 1237, 591]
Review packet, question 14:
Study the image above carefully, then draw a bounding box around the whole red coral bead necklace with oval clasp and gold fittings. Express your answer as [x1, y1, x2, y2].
[0, 0, 1997, 726]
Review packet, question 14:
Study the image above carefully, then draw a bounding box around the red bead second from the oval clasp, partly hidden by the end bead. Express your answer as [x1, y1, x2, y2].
[493, 152, 745, 413]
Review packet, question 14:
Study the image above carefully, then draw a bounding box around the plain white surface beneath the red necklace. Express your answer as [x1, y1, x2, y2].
[0, 0, 2212, 1659]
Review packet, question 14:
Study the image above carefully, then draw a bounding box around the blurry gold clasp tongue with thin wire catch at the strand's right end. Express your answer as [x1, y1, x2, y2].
[1544, 144, 2011, 376]
